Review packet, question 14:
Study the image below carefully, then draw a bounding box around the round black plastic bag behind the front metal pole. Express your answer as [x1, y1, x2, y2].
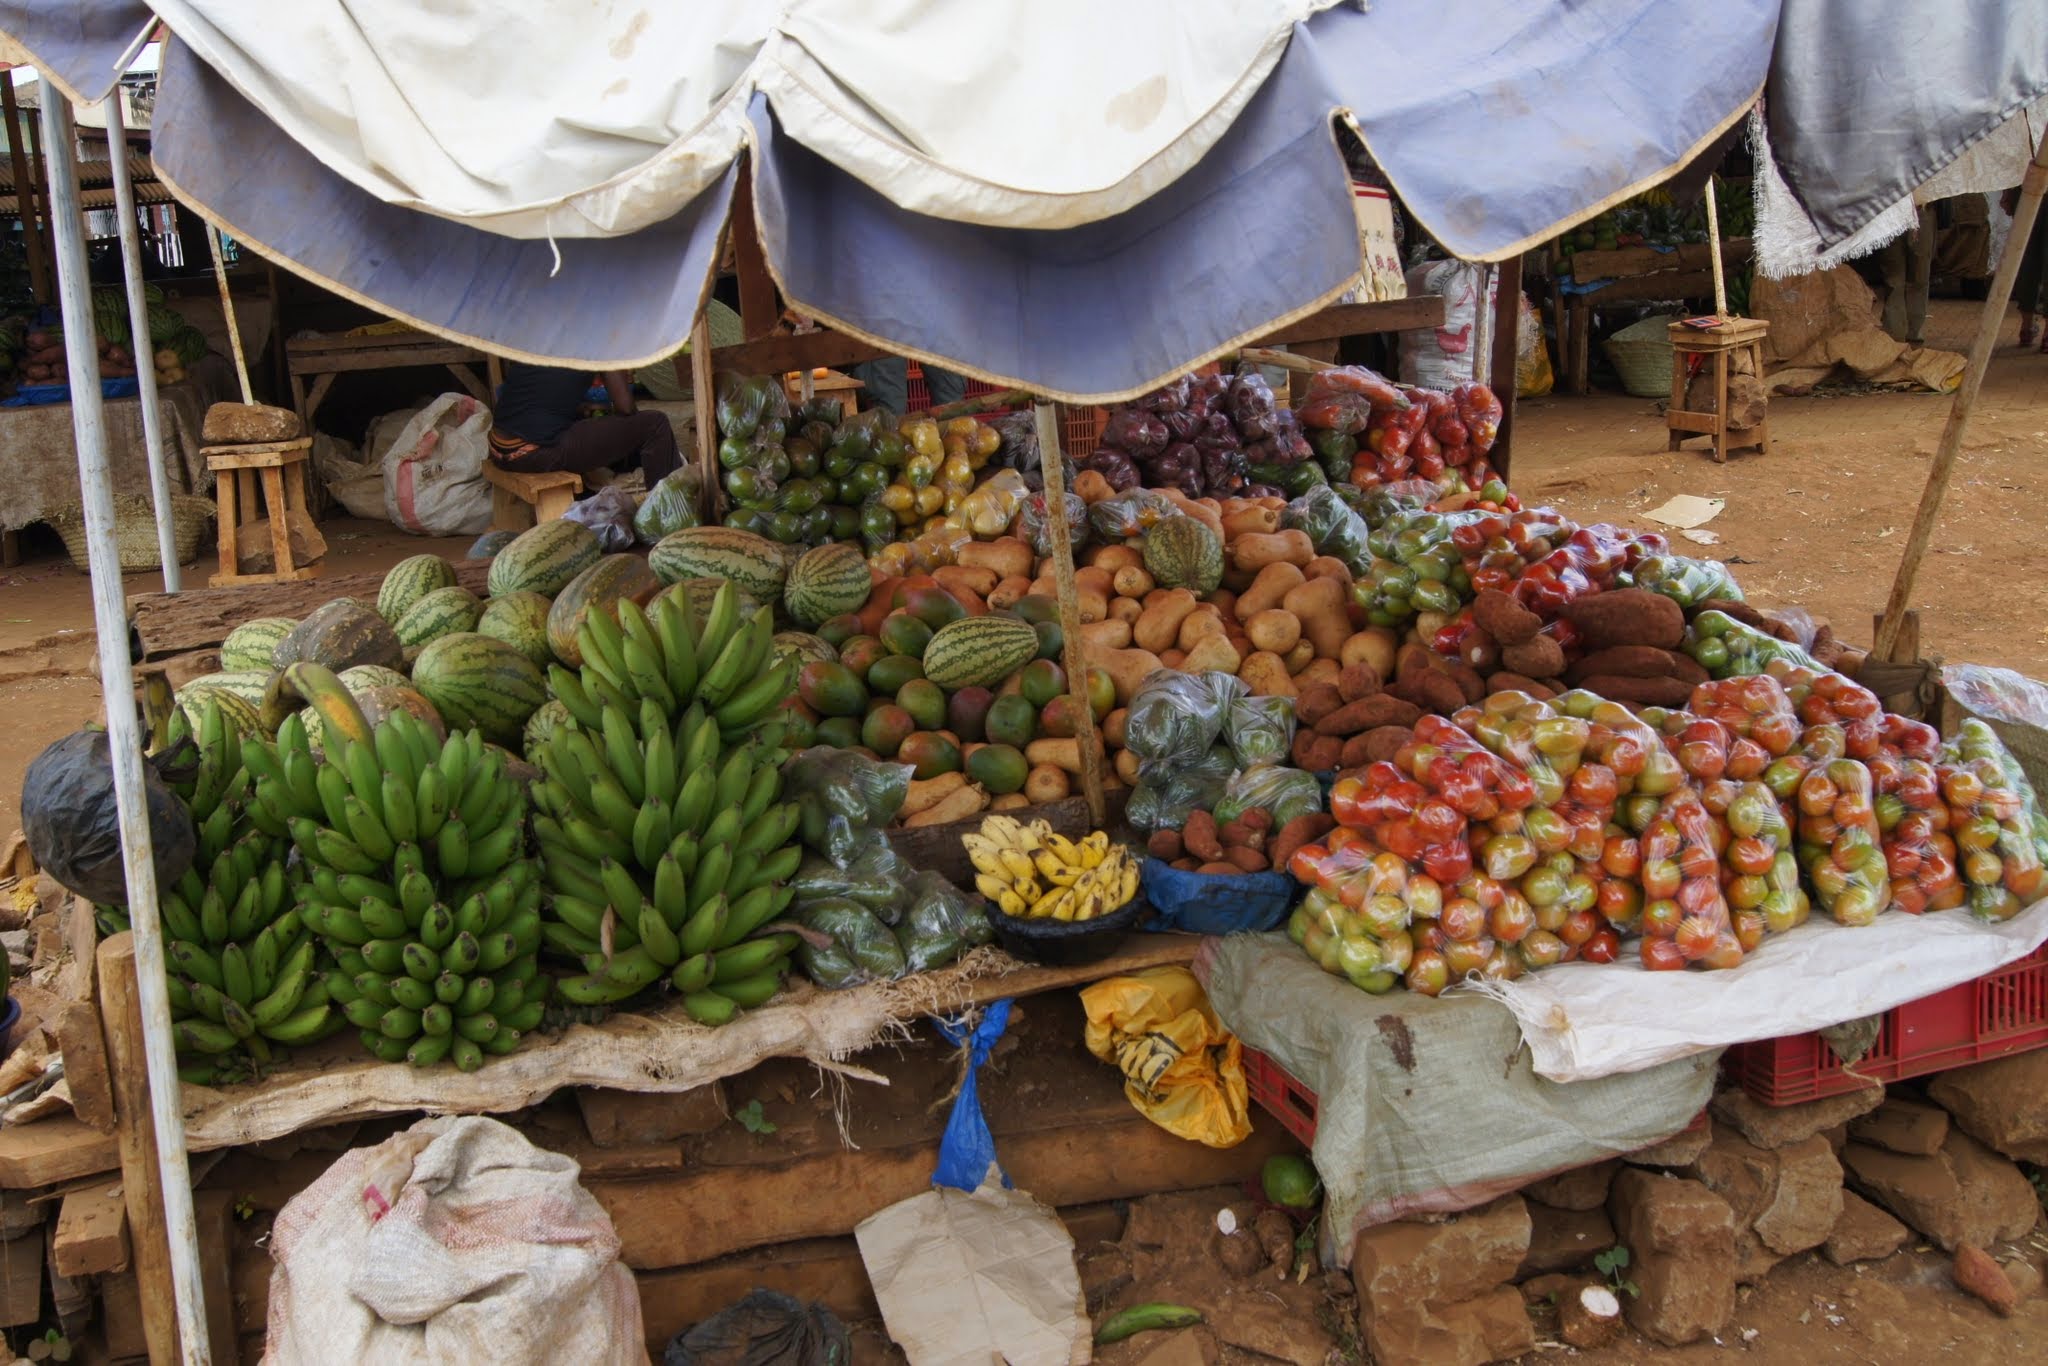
[20, 731, 199, 905]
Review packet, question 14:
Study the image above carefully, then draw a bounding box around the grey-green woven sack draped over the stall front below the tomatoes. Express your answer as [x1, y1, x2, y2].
[1196, 932, 1712, 1266]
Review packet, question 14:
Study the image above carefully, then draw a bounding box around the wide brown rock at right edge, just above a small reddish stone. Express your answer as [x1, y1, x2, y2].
[1841, 1128, 2040, 1251]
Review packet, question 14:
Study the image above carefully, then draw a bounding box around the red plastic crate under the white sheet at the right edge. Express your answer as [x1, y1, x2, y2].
[1720, 946, 2048, 1106]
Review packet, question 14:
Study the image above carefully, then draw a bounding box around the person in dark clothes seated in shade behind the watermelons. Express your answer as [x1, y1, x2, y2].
[492, 360, 676, 487]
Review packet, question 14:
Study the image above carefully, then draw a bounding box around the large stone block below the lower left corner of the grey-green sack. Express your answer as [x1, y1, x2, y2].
[1352, 1196, 1536, 1366]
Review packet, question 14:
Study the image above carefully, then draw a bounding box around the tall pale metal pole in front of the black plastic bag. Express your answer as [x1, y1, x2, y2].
[41, 82, 211, 1366]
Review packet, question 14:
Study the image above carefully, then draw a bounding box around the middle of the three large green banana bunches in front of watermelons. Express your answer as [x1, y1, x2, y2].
[292, 711, 549, 1071]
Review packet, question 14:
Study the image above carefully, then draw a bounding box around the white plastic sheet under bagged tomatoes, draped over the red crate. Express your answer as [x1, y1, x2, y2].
[1466, 901, 2048, 1081]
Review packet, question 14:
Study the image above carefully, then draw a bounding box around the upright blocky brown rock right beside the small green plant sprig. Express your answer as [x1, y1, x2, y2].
[1608, 1169, 1735, 1348]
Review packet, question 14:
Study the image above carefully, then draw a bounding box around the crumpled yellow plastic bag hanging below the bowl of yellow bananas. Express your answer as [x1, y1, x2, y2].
[1081, 967, 1251, 1147]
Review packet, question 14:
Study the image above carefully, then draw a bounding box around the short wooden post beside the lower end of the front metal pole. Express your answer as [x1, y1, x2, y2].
[98, 934, 182, 1362]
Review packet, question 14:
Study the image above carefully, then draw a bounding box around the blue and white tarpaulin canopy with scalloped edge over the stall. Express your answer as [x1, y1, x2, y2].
[0, 0, 2048, 401]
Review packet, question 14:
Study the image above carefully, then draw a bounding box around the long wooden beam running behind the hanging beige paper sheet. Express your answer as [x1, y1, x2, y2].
[588, 1108, 1298, 1270]
